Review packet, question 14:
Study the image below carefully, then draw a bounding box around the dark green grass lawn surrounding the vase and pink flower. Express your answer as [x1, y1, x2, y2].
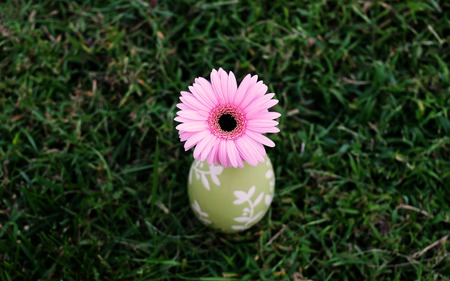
[0, 0, 450, 281]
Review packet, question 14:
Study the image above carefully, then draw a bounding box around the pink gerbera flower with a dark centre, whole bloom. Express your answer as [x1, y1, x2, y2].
[175, 68, 281, 168]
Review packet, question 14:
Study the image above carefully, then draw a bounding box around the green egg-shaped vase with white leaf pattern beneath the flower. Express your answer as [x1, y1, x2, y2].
[188, 156, 275, 233]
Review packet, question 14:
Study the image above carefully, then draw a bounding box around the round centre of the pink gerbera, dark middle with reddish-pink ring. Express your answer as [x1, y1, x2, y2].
[208, 104, 247, 140]
